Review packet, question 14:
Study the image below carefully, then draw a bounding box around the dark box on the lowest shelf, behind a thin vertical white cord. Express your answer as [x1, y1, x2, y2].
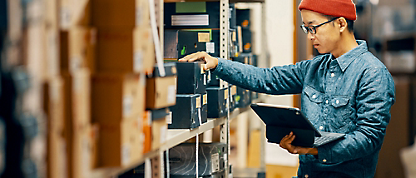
[169, 143, 228, 178]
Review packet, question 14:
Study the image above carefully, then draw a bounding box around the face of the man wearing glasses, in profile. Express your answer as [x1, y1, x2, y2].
[301, 10, 340, 53]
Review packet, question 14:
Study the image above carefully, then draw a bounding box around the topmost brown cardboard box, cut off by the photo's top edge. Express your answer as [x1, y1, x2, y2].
[91, 0, 150, 28]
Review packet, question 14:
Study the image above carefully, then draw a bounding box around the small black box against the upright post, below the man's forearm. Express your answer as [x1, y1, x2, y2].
[207, 87, 228, 118]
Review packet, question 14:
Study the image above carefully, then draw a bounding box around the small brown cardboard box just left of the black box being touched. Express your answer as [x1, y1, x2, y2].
[146, 76, 176, 109]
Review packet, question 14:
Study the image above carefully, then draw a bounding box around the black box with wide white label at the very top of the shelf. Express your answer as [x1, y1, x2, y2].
[163, 2, 220, 29]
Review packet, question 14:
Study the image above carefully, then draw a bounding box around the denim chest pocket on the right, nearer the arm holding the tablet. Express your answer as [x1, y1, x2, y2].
[331, 96, 353, 132]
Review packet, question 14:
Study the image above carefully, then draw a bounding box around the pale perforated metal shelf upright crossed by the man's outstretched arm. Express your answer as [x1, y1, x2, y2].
[220, 0, 230, 178]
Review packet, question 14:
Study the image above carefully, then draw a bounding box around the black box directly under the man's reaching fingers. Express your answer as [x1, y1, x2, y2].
[176, 62, 209, 94]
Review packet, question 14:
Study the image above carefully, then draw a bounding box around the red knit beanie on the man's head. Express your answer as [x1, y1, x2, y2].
[299, 0, 357, 20]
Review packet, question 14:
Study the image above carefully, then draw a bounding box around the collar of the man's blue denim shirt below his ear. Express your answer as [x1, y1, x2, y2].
[335, 40, 368, 72]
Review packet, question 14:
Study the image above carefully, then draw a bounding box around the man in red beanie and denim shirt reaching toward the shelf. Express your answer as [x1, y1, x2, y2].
[179, 0, 395, 178]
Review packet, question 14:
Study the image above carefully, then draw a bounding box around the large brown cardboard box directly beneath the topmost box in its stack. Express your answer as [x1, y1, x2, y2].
[96, 28, 155, 73]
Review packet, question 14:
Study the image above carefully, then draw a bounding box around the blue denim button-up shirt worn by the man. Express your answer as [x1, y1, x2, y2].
[214, 40, 395, 178]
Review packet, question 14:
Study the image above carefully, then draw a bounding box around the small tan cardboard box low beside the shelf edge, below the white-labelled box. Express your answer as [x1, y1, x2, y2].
[152, 116, 168, 150]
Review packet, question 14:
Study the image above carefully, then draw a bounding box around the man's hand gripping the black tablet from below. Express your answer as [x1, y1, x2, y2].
[279, 132, 318, 155]
